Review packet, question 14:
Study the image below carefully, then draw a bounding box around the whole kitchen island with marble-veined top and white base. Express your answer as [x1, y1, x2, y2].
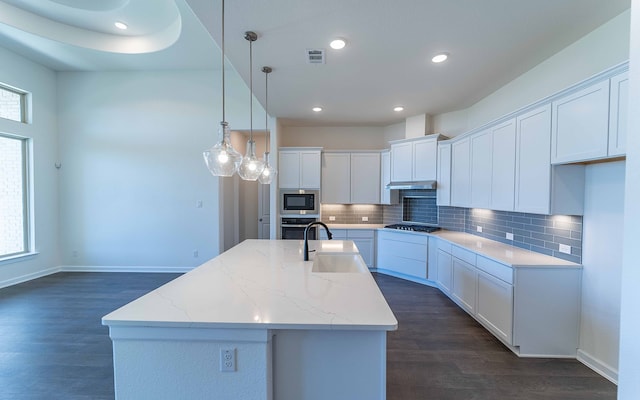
[102, 240, 397, 400]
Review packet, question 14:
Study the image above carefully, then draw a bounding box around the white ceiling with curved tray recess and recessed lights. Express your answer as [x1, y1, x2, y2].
[0, 0, 630, 126]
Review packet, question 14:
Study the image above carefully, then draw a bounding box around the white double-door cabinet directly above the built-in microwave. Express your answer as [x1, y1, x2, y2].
[278, 147, 321, 189]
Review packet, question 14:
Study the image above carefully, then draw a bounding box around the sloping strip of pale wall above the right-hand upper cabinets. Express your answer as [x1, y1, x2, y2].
[432, 11, 630, 137]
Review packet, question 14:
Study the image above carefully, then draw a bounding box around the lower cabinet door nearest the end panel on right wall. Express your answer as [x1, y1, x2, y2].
[476, 271, 513, 344]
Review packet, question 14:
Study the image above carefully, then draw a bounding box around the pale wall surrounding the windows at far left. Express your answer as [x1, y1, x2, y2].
[0, 47, 58, 287]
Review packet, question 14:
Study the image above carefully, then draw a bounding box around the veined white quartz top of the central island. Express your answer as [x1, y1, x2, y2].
[102, 240, 398, 330]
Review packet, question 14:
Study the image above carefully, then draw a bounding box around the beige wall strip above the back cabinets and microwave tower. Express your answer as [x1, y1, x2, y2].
[278, 125, 388, 150]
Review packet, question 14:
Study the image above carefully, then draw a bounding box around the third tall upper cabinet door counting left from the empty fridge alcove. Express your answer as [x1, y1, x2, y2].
[470, 130, 492, 208]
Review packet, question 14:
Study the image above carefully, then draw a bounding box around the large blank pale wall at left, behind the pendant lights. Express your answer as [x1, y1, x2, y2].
[58, 71, 259, 270]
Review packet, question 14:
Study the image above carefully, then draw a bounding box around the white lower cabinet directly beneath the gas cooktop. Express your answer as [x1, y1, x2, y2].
[376, 231, 429, 279]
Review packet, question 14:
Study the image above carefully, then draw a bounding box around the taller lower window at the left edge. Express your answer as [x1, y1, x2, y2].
[0, 134, 30, 258]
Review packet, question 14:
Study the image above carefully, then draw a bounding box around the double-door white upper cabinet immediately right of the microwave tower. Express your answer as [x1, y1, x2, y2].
[322, 152, 380, 204]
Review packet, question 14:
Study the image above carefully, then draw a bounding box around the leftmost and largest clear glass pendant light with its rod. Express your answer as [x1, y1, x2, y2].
[202, 0, 242, 176]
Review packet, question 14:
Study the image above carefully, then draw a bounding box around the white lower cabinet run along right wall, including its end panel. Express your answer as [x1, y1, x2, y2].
[436, 240, 582, 357]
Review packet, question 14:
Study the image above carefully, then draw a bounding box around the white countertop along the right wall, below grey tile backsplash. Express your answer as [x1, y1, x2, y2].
[429, 230, 582, 268]
